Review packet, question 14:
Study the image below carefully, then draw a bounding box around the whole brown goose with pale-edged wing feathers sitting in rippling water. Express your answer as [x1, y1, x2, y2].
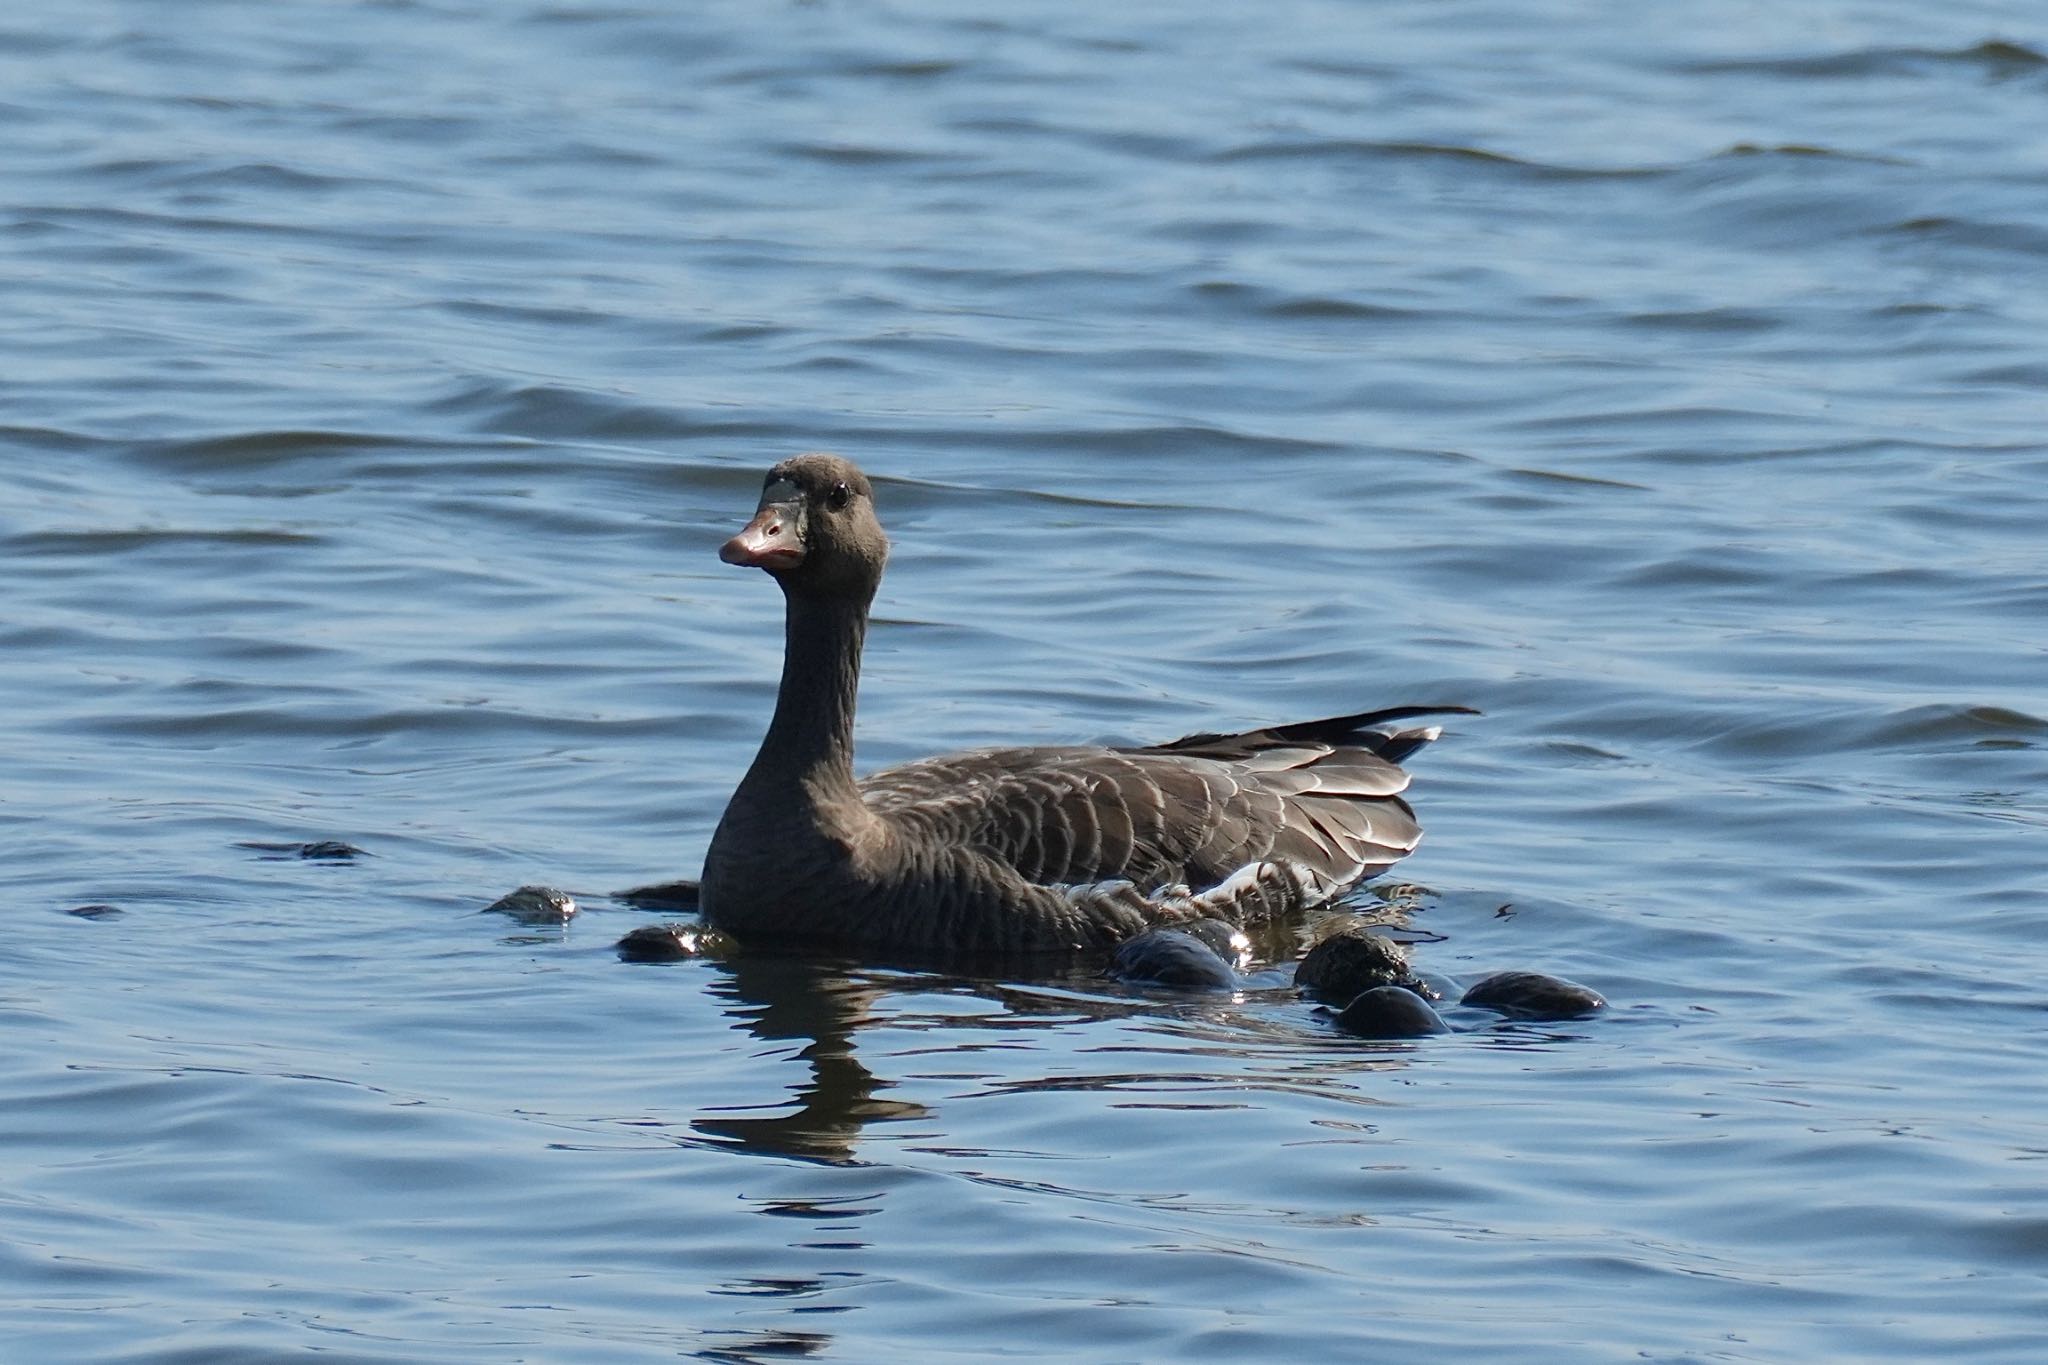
[700, 454, 1468, 954]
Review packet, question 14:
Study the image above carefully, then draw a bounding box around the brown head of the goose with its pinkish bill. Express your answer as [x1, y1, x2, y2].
[719, 454, 889, 600]
